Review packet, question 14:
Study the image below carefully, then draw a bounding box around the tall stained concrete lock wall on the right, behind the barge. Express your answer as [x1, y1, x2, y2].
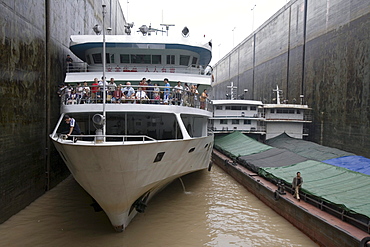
[212, 0, 370, 157]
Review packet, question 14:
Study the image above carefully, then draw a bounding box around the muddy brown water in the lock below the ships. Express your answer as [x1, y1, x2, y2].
[0, 166, 318, 247]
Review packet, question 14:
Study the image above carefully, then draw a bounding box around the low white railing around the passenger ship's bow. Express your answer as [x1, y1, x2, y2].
[56, 134, 158, 144]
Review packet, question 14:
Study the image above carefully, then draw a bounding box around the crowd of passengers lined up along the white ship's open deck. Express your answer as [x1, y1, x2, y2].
[58, 78, 208, 109]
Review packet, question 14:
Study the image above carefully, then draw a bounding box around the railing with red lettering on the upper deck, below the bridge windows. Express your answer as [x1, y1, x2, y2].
[66, 62, 206, 75]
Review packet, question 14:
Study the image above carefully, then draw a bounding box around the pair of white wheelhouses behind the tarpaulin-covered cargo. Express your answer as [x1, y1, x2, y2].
[210, 83, 312, 140]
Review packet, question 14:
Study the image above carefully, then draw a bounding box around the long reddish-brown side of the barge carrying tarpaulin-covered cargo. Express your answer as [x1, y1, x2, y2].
[212, 150, 369, 247]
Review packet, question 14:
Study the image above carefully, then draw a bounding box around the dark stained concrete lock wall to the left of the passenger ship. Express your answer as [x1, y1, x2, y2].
[0, 0, 124, 223]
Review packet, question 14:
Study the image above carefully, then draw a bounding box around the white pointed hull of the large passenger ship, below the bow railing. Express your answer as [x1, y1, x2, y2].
[53, 136, 213, 230]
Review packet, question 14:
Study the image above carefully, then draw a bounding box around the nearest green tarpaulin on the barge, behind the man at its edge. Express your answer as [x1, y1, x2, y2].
[259, 160, 370, 217]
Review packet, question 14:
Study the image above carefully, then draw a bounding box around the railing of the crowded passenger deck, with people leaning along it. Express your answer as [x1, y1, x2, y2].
[58, 83, 212, 111]
